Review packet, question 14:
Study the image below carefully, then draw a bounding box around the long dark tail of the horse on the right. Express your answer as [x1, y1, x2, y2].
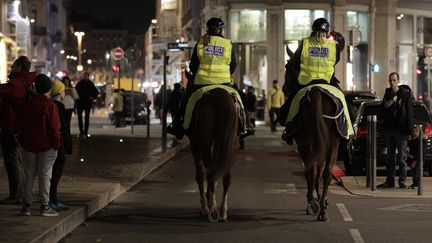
[310, 88, 329, 163]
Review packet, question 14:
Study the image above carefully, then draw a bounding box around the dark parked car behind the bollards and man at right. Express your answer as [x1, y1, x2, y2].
[344, 101, 432, 175]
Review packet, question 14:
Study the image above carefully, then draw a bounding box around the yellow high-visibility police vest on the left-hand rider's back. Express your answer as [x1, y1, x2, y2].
[194, 36, 232, 85]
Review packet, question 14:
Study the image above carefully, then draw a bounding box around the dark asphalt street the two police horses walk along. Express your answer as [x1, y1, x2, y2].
[63, 126, 432, 243]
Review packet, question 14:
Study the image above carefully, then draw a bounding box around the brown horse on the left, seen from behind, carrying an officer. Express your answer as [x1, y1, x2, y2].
[187, 88, 239, 222]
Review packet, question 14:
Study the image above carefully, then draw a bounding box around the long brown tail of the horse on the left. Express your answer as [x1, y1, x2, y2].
[208, 89, 238, 178]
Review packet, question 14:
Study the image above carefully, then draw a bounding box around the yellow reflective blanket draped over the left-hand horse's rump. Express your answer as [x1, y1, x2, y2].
[183, 84, 246, 130]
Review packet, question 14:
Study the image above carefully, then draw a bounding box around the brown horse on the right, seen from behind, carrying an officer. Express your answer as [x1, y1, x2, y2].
[285, 47, 341, 221]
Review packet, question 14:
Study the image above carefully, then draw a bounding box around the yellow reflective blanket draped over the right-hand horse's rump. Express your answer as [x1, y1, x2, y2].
[285, 84, 354, 139]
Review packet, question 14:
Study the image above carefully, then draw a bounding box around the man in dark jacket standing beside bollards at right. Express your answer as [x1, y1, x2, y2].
[377, 72, 414, 188]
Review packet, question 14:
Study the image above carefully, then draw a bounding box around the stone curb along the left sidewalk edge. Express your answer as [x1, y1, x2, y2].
[30, 139, 189, 243]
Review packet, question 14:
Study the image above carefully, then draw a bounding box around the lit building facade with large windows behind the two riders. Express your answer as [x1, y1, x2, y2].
[174, 0, 432, 100]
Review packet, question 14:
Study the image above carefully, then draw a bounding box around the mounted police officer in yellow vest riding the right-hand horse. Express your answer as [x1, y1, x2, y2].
[280, 18, 340, 144]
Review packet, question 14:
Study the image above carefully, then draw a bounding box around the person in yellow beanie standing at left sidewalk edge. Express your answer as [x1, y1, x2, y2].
[49, 80, 72, 212]
